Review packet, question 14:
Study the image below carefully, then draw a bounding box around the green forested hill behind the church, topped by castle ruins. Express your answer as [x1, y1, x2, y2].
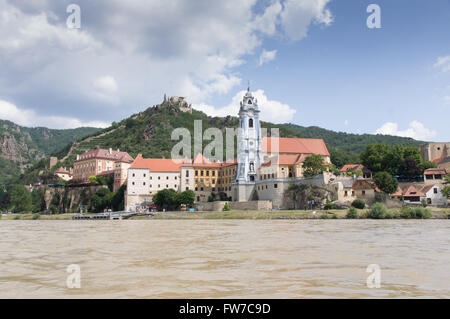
[25, 100, 421, 176]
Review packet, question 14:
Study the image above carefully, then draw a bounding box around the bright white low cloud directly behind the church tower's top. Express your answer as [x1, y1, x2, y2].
[193, 90, 296, 123]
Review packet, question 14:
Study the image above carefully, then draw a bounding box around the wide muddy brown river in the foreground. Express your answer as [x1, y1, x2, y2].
[0, 220, 450, 298]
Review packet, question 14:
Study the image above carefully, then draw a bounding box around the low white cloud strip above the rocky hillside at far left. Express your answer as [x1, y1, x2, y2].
[0, 100, 110, 129]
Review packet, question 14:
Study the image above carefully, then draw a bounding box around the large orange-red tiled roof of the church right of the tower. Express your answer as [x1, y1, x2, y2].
[261, 137, 330, 156]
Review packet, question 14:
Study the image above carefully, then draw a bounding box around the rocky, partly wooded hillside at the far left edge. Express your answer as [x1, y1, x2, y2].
[0, 120, 99, 184]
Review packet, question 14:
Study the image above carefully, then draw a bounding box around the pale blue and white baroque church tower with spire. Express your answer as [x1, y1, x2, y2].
[232, 86, 261, 201]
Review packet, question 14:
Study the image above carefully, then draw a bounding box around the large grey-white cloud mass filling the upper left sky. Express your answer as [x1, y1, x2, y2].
[0, 0, 332, 129]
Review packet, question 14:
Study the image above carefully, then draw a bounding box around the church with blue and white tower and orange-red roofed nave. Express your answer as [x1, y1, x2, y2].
[231, 88, 331, 208]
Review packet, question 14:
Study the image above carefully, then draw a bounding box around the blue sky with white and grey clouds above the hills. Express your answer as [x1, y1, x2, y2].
[0, 0, 450, 141]
